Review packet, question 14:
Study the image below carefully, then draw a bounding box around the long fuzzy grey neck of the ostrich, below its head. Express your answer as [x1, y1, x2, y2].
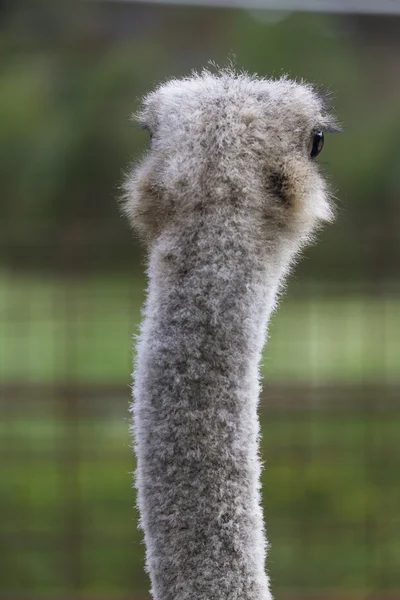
[133, 215, 284, 600]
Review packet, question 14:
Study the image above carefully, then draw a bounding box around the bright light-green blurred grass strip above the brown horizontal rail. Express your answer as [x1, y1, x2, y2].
[0, 273, 400, 383]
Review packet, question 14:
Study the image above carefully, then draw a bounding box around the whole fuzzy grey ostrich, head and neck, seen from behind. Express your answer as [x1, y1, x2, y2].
[124, 70, 336, 600]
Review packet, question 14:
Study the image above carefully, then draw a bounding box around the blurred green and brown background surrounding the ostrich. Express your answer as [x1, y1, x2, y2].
[0, 0, 400, 600]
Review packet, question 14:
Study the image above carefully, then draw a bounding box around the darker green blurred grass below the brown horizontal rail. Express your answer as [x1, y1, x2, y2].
[0, 414, 400, 597]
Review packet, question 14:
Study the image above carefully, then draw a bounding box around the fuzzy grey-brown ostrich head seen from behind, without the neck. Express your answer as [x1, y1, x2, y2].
[124, 71, 336, 250]
